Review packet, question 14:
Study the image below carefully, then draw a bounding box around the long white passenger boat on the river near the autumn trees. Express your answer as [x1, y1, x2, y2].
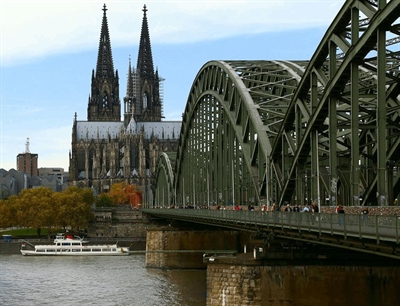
[21, 234, 129, 256]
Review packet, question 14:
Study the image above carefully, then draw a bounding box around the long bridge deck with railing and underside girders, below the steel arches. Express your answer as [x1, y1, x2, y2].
[143, 208, 400, 259]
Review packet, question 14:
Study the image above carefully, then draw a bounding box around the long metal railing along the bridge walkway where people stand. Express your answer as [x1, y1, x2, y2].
[143, 209, 400, 243]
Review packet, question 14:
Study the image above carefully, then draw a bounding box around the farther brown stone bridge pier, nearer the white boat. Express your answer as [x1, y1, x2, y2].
[146, 226, 239, 269]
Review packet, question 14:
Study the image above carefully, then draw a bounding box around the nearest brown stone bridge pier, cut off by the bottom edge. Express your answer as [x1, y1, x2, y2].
[205, 253, 400, 306]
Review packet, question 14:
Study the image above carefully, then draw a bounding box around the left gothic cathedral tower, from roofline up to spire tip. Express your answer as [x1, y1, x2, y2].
[87, 4, 121, 121]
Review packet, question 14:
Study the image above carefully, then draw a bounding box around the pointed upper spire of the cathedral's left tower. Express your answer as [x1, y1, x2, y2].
[96, 4, 114, 77]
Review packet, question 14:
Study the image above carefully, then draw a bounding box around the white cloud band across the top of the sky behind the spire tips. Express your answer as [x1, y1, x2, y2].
[0, 0, 343, 66]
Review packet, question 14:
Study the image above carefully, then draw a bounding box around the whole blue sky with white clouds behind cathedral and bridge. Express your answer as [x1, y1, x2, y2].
[0, 0, 344, 171]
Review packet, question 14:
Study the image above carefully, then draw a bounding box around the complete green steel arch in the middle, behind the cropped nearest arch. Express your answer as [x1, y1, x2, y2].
[175, 61, 306, 206]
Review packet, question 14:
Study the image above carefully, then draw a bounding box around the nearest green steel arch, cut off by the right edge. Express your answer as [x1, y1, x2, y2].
[271, 1, 400, 205]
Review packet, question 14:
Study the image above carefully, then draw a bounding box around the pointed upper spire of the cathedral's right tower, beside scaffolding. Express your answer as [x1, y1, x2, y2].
[136, 4, 154, 78]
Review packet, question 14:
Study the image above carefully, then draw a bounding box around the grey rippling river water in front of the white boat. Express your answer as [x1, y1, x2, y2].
[0, 254, 206, 306]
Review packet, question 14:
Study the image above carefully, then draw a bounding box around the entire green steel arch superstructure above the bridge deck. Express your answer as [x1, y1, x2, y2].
[155, 0, 400, 206]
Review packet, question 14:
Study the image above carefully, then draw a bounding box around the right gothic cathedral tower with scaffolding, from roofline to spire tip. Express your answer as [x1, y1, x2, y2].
[124, 5, 162, 124]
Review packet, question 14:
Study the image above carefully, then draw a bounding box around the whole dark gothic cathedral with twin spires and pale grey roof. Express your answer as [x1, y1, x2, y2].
[69, 4, 181, 205]
